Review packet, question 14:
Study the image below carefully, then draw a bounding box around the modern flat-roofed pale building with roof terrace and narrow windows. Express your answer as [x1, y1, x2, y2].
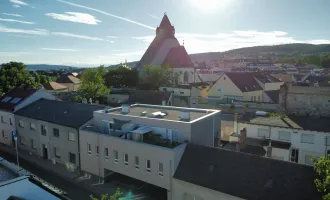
[79, 104, 221, 199]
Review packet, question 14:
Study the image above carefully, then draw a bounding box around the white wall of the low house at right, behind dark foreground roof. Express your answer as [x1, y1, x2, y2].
[239, 123, 330, 164]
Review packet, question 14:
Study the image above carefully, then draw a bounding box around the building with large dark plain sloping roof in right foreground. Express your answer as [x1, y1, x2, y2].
[172, 144, 321, 200]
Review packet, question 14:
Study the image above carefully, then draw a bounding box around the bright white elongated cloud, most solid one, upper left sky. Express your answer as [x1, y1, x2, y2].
[45, 12, 102, 25]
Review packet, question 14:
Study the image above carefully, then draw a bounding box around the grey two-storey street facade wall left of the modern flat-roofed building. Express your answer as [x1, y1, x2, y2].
[15, 115, 79, 168]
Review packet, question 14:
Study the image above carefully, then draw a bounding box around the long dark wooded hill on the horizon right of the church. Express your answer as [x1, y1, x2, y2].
[190, 44, 330, 61]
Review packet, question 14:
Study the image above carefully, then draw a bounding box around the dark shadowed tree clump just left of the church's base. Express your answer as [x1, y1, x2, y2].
[104, 66, 139, 88]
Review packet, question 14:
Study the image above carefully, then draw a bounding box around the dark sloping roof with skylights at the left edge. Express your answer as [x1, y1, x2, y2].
[0, 86, 38, 112]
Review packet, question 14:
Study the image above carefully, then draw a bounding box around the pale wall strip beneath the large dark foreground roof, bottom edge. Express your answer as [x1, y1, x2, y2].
[172, 177, 243, 200]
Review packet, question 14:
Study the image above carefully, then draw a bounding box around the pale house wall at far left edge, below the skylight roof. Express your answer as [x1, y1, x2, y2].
[0, 110, 15, 146]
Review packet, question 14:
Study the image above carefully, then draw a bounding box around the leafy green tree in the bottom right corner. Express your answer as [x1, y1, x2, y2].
[313, 157, 330, 200]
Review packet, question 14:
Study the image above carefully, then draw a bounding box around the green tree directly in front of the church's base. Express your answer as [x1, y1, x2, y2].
[139, 66, 175, 90]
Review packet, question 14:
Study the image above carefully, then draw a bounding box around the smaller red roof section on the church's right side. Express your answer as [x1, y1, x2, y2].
[163, 46, 194, 68]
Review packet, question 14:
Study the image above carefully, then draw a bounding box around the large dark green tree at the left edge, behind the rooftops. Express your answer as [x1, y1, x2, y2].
[0, 62, 41, 94]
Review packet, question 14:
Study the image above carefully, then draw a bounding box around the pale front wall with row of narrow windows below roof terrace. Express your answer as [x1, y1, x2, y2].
[80, 130, 185, 190]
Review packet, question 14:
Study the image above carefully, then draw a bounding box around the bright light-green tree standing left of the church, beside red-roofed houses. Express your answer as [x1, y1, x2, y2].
[80, 68, 109, 100]
